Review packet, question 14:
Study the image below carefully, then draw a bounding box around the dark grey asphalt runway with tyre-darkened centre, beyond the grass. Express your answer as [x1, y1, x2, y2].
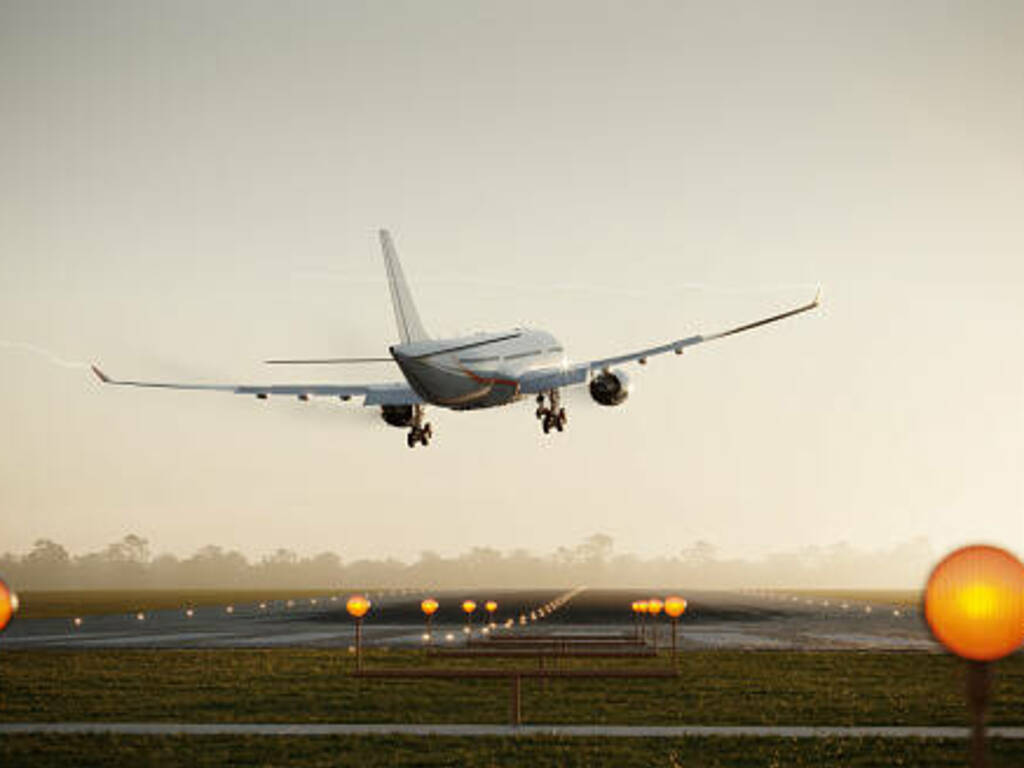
[0, 590, 938, 651]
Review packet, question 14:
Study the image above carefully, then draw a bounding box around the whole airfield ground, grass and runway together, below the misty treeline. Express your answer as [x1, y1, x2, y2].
[0, 591, 1024, 766]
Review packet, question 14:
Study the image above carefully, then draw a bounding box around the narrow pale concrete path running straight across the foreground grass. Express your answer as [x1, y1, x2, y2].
[0, 723, 1024, 739]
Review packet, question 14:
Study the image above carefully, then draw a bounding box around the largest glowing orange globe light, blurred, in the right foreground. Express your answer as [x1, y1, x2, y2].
[925, 545, 1024, 662]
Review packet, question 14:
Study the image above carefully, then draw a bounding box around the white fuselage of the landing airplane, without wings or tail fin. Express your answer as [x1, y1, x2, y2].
[390, 329, 567, 411]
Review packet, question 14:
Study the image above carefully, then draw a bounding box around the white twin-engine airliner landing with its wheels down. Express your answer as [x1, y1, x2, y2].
[92, 229, 820, 447]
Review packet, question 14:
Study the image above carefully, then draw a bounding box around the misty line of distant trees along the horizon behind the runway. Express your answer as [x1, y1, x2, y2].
[0, 534, 935, 591]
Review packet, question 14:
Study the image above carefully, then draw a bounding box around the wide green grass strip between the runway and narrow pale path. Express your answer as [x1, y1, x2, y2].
[0, 648, 1024, 725]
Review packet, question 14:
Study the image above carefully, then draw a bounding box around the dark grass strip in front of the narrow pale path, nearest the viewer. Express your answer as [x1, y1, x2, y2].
[0, 735, 1024, 768]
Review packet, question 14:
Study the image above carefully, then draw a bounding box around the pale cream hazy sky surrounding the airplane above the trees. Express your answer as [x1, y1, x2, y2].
[0, 0, 1024, 573]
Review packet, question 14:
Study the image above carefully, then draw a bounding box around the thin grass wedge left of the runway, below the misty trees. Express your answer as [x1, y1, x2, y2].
[17, 589, 340, 618]
